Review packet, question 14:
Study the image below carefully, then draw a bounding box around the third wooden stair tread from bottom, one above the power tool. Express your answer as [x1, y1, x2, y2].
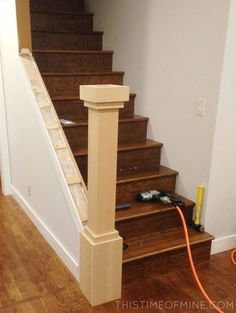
[117, 165, 178, 184]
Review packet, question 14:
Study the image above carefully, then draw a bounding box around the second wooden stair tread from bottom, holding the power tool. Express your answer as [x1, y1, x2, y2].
[116, 195, 194, 222]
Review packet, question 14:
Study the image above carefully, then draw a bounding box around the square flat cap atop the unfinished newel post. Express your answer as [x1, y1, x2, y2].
[80, 85, 130, 108]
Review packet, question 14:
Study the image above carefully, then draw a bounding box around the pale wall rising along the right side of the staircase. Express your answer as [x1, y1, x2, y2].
[88, 0, 230, 229]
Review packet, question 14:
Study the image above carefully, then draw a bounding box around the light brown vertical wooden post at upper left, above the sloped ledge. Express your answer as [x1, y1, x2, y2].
[16, 0, 32, 52]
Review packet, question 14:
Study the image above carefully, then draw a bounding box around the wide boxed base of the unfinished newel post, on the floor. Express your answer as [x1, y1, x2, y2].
[80, 228, 123, 306]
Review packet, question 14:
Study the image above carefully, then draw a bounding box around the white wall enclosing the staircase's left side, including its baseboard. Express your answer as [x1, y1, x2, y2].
[0, 0, 82, 275]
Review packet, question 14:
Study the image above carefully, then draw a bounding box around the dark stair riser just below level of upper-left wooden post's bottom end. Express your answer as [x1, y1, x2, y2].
[34, 52, 112, 73]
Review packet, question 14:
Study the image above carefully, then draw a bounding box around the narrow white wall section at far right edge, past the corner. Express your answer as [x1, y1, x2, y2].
[205, 0, 236, 252]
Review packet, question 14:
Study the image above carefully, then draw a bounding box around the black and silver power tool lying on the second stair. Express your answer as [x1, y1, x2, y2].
[136, 190, 185, 208]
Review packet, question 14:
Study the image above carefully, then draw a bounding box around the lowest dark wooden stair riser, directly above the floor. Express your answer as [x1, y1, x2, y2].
[123, 241, 211, 283]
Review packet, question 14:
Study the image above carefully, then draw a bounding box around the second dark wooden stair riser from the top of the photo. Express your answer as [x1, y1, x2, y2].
[31, 13, 93, 32]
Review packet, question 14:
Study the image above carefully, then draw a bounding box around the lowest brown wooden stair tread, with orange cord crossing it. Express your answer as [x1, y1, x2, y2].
[123, 227, 214, 263]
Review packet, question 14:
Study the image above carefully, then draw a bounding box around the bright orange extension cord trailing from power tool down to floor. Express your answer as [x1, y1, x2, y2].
[176, 206, 236, 313]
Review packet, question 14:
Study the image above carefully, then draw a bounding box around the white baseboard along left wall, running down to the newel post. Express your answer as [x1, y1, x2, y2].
[11, 186, 79, 280]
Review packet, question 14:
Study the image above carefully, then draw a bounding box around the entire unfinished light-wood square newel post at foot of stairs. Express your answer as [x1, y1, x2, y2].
[80, 85, 129, 305]
